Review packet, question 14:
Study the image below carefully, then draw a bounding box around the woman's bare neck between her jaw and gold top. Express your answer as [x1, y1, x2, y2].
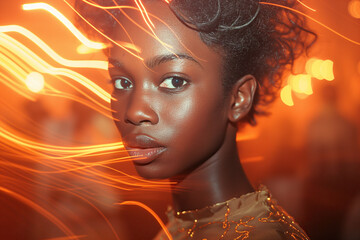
[172, 125, 253, 211]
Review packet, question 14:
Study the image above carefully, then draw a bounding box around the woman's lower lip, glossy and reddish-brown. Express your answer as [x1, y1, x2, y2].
[126, 147, 166, 165]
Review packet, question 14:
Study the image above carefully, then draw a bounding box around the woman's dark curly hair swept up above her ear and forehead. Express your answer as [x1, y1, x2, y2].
[75, 0, 317, 124]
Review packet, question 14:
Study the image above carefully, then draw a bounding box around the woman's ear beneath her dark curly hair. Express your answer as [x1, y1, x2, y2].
[228, 75, 257, 123]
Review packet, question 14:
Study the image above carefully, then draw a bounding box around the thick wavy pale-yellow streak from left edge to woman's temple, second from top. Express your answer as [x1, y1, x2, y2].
[0, 25, 108, 70]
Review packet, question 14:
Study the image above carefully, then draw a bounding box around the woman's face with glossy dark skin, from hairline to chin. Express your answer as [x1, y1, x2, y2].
[109, 1, 228, 179]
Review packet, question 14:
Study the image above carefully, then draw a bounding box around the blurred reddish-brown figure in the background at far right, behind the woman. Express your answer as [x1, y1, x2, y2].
[304, 85, 359, 240]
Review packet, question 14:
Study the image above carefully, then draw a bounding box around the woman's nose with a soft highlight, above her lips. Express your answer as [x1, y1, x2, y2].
[125, 89, 159, 125]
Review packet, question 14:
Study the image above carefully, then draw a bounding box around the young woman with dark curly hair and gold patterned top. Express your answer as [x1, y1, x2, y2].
[77, 0, 314, 240]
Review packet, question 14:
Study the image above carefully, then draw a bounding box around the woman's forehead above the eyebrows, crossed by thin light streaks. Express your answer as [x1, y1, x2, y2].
[108, 1, 211, 60]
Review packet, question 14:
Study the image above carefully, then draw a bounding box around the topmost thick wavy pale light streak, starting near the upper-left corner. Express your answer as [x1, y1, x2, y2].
[22, 3, 106, 49]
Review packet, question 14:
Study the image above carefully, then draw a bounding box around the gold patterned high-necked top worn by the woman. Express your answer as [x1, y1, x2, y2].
[155, 187, 309, 240]
